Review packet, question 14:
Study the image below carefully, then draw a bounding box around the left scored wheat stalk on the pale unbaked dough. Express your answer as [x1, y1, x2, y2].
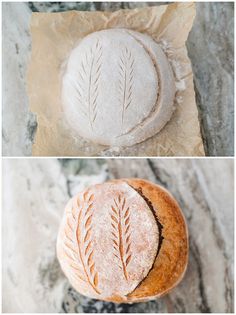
[74, 40, 102, 129]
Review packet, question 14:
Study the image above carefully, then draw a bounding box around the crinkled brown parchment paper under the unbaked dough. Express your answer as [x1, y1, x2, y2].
[27, 3, 204, 156]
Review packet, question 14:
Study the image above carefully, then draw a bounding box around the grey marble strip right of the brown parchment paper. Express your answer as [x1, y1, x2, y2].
[187, 2, 234, 156]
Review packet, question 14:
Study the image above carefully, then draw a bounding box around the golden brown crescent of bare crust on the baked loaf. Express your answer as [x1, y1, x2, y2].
[126, 179, 188, 299]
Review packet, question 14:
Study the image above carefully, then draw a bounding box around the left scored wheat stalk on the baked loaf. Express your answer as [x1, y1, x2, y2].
[65, 191, 100, 294]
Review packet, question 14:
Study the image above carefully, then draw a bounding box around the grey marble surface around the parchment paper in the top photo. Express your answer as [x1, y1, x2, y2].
[2, 2, 234, 156]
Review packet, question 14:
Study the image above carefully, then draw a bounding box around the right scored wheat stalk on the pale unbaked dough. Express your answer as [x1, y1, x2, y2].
[119, 47, 134, 126]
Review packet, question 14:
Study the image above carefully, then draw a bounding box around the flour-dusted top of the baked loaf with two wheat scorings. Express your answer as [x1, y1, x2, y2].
[56, 182, 159, 299]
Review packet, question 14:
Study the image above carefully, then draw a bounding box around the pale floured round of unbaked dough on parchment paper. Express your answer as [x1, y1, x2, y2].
[62, 29, 175, 146]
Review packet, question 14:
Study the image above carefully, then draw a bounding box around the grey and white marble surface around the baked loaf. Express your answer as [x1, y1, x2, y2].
[2, 158, 234, 313]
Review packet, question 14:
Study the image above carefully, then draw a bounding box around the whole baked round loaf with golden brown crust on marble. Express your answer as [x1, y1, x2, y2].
[57, 179, 188, 303]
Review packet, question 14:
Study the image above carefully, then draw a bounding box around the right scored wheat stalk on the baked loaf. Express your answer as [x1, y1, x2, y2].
[110, 195, 132, 280]
